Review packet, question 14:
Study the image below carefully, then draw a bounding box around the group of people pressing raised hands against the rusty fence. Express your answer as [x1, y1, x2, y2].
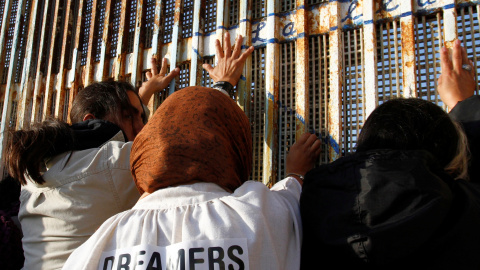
[0, 33, 480, 270]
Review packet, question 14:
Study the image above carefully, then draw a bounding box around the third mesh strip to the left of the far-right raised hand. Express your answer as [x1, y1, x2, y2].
[342, 28, 365, 154]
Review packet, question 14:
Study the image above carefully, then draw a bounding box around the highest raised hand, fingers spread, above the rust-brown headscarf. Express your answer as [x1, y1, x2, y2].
[203, 32, 254, 85]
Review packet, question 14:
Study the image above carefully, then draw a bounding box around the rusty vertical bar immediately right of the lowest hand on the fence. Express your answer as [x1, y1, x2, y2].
[327, 1, 343, 160]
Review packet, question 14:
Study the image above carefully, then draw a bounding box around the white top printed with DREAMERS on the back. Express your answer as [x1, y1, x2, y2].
[63, 177, 302, 270]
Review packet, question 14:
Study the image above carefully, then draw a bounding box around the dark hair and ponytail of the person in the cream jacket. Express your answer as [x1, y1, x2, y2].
[4, 81, 136, 185]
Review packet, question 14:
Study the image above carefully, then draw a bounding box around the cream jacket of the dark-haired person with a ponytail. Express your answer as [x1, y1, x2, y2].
[19, 131, 140, 270]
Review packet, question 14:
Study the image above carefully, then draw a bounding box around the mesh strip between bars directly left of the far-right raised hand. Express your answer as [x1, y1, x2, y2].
[415, 13, 443, 105]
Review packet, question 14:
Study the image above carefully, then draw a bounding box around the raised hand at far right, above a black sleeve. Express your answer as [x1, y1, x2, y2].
[437, 40, 476, 109]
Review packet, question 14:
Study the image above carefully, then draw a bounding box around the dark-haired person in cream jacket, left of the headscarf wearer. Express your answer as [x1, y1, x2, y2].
[5, 82, 145, 269]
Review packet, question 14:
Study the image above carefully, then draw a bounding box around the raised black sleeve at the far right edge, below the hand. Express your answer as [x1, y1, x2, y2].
[450, 96, 480, 183]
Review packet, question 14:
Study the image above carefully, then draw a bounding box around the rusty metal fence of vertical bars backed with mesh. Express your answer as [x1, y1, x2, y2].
[0, 0, 480, 185]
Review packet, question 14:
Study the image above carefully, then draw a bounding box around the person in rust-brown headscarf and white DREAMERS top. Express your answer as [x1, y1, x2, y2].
[64, 33, 320, 269]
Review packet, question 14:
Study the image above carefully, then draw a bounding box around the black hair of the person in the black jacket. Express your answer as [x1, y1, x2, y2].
[357, 98, 467, 178]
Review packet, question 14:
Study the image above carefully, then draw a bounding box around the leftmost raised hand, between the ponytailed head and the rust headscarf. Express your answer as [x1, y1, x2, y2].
[138, 57, 180, 105]
